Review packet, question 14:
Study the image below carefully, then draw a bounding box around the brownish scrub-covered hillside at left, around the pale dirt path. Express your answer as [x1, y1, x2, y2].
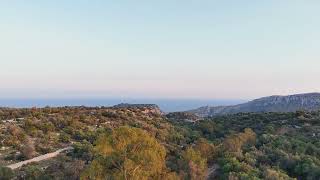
[0, 105, 175, 180]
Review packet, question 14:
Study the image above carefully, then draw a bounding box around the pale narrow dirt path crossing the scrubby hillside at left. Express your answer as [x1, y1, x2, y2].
[7, 147, 73, 170]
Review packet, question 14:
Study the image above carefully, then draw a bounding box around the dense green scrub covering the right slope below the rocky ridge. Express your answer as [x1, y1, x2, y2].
[174, 112, 320, 179]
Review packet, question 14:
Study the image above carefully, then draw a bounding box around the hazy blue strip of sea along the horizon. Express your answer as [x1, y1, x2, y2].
[0, 98, 245, 112]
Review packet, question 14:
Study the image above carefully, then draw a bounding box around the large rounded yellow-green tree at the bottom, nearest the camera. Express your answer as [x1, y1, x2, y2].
[81, 126, 166, 180]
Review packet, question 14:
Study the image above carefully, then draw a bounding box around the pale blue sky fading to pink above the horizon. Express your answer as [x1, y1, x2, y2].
[0, 0, 320, 99]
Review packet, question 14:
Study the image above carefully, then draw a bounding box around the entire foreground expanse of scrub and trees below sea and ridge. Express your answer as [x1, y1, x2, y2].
[0, 107, 320, 180]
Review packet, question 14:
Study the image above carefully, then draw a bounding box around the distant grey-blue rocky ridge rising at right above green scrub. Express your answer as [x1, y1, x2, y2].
[189, 93, 320, 117]
